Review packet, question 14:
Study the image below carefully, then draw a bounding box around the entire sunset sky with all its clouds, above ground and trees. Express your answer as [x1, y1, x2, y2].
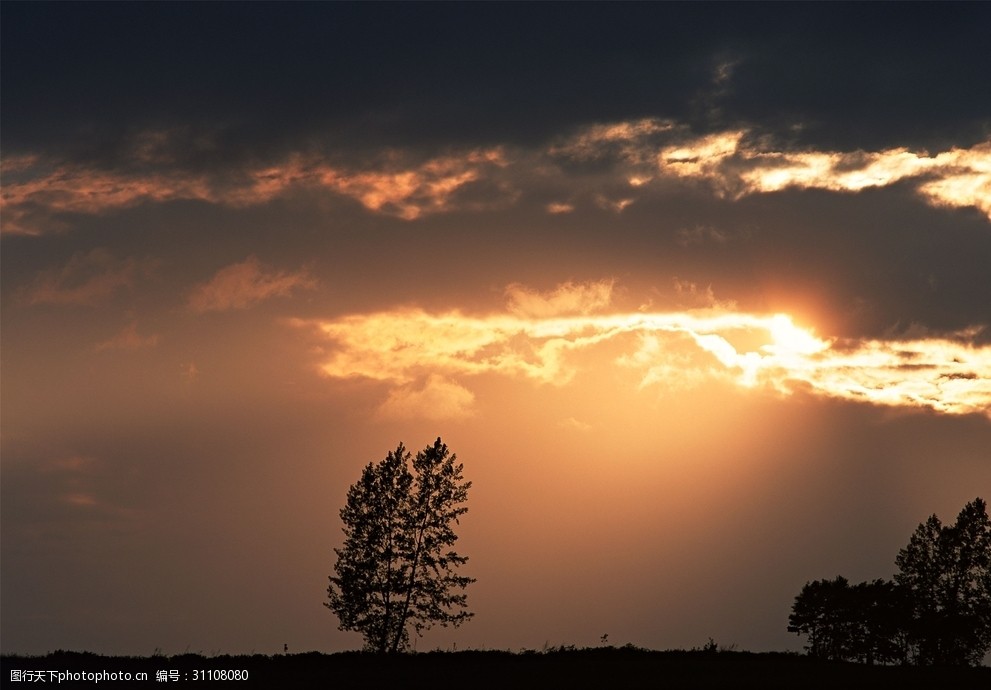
[0, 2, 991, 655]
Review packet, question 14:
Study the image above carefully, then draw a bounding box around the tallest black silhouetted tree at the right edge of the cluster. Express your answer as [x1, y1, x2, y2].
[895, 498, 991, 665]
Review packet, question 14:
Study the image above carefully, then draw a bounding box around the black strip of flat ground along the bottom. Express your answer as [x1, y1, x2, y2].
[0, 647, 991, 690]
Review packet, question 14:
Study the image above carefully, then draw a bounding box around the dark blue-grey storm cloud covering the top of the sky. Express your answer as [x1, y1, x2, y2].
[2, 3, 991, 164]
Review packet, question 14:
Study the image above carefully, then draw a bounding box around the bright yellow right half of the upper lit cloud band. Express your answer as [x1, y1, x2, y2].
[547, 118, 991, 218]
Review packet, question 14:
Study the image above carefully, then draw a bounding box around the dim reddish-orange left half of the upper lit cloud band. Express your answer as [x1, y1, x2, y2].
[0, 148, 513, 234]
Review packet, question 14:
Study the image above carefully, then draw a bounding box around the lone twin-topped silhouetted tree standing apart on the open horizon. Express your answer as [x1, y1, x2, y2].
[324, 438, 474, 652]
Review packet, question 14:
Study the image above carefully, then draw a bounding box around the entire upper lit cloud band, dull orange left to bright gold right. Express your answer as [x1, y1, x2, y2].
[0, 118, 991, 234]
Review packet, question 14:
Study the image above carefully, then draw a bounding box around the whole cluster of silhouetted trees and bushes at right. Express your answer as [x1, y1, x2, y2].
[788, 498, 991, 665]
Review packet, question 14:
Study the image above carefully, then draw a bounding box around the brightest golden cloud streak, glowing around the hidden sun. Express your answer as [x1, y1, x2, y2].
[296, 285, 991, 417]
